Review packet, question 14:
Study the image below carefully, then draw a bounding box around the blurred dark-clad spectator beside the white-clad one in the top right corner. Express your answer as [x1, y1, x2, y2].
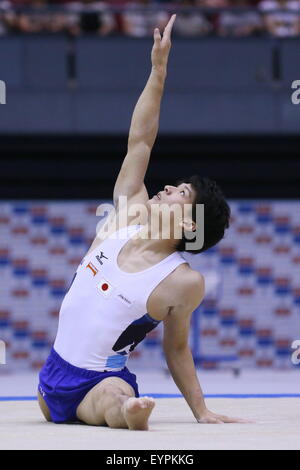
[218, 0, 263, 36]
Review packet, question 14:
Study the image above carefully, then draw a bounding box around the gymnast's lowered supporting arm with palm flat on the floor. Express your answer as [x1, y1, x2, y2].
[163, 271, 249, 424]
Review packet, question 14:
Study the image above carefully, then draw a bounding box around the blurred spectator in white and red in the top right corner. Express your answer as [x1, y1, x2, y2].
[259, 0, 300, 37]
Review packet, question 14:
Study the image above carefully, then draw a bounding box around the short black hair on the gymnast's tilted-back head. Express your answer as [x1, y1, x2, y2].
[176, 175, 231, 254]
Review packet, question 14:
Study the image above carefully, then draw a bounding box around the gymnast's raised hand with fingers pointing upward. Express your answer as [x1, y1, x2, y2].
[151, 14, 176, 69]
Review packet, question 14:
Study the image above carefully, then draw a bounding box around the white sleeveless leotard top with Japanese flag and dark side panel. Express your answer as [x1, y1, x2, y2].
[54, 225, 186, 371]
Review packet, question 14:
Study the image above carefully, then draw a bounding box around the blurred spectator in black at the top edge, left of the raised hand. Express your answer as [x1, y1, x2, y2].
[66, 0, 116, 36]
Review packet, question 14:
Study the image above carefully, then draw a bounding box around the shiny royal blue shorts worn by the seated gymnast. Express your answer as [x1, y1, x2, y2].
[38, 347, 139, 423]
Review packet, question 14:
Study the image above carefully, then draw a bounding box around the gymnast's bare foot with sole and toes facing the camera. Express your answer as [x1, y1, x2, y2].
[122, 397, 155, 431]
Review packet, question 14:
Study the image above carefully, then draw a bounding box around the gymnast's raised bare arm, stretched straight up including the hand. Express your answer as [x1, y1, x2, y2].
[113, 15, 176, 207]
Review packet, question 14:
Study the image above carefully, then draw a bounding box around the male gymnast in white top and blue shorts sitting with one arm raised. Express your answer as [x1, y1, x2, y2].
[38, 15, 245, 430]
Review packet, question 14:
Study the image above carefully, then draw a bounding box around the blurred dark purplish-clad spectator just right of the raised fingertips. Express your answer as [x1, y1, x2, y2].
[173, 0, 212, 36]
